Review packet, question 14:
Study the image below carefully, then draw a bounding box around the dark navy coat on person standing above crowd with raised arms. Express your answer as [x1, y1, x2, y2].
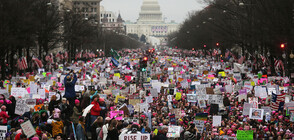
[64, 74, 77, 98]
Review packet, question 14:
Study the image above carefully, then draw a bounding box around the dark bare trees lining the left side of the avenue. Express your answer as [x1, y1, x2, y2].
[0, 0, 139, 78]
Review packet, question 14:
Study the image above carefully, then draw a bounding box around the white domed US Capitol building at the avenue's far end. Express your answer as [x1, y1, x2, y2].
[125, 0, 179, 45]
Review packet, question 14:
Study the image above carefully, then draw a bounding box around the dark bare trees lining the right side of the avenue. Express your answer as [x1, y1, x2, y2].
[169, 0, 294, 55]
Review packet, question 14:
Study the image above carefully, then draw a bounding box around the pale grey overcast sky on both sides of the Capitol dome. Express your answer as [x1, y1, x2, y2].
[101, 0, 205, 23]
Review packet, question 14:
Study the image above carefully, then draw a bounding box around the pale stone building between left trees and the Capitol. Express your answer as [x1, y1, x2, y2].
[100, 6, 125, 34]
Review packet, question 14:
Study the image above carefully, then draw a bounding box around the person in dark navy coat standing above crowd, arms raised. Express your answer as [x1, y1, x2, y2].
[64, 70, 77, 109]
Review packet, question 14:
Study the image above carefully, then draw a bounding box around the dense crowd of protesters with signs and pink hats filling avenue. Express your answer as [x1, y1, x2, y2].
[0, 50, 294, 140]
